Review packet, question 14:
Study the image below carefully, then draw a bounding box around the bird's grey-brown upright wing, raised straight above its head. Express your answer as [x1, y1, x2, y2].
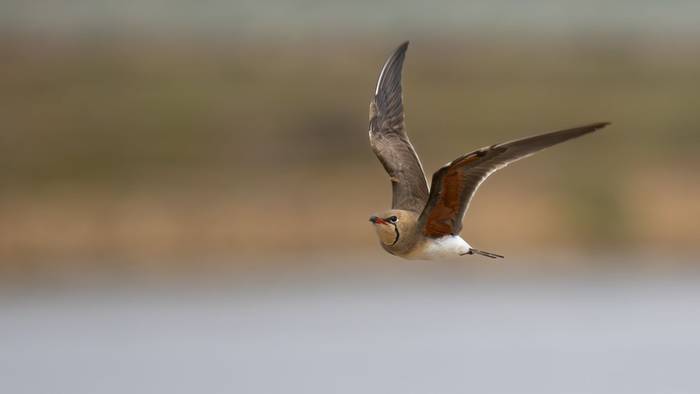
[369, 41, 428, 213]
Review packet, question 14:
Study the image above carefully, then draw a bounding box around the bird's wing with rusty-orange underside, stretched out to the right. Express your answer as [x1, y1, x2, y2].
[418, 123, 609, 238]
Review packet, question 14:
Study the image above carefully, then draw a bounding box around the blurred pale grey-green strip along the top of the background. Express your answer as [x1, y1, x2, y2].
[0, 0, 700, 36]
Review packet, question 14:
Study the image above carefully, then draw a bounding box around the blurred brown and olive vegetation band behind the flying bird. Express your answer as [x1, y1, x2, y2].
[0, 36, 700, 273]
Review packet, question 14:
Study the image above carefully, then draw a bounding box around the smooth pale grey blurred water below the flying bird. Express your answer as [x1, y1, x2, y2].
[0, 265, 700, 394]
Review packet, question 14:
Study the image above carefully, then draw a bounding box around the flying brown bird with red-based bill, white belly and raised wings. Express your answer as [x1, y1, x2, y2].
[369, 41, 610, 260]
